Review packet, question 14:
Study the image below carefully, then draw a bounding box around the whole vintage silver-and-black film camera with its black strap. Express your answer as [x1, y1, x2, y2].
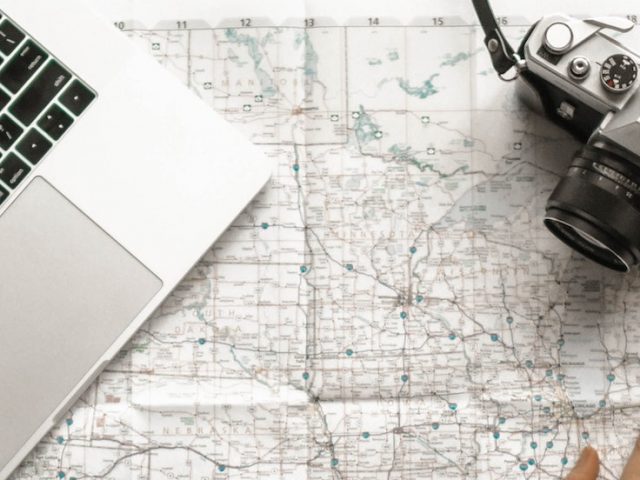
[473, 0, 640, 272]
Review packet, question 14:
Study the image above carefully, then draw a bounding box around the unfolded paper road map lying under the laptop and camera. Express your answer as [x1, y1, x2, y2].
[16, 0, 640, 480]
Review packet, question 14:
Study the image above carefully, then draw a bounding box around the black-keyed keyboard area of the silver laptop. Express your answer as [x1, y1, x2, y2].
[0, 13, 96, 205]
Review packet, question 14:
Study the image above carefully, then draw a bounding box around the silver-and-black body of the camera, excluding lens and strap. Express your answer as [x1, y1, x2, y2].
[518, 14, 640, 146]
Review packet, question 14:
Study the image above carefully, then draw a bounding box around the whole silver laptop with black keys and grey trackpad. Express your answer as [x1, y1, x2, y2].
[0, 0, 271, 479]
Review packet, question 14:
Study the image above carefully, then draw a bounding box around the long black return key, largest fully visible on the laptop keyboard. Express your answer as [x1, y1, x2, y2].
[9, 60, 71, 125]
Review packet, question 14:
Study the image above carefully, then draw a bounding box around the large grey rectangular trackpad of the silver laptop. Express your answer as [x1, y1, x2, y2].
[0, 177, 162, 470]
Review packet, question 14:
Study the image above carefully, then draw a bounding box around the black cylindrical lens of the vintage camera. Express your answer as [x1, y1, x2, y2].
[544, 146, 640, 272]
